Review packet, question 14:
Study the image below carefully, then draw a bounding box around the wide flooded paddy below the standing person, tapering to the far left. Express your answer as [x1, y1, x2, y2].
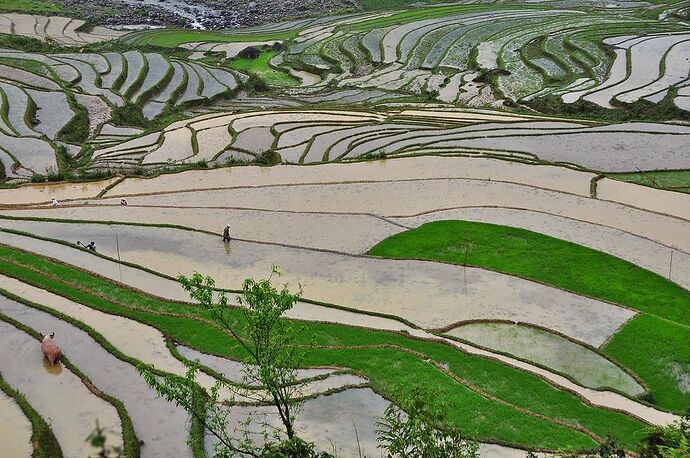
[2, 221, 633, 346]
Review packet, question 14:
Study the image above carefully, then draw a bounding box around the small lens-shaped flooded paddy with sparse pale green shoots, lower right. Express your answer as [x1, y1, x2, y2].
[447, 323, 644, 396]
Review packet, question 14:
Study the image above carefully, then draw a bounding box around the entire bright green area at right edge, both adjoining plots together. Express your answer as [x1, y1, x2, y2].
[369, 221, 690, 412]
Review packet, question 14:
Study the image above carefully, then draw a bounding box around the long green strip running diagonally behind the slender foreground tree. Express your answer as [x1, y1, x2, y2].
[0, 246, 656, 449]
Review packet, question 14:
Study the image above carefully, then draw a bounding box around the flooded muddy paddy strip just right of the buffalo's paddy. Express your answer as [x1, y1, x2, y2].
[0, 297, 192, 458]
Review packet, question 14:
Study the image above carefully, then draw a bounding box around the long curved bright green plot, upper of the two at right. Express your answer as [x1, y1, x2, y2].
[369, 221, 690, 325]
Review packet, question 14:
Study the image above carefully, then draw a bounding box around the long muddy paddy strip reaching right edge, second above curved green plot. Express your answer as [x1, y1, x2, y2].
[97, 179, 690, 253]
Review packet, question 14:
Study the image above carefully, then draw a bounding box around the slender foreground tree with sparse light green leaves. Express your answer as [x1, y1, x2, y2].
[140, 266, 313, 457]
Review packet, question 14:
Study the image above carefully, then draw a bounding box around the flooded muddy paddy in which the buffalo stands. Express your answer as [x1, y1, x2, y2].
[0, 312, 122, 457]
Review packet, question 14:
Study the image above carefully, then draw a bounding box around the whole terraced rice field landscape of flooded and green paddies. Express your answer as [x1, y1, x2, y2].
[0, 1, 690, 458]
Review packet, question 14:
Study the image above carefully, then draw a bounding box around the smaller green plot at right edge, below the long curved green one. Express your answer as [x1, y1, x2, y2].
[603, 315, 690, 413]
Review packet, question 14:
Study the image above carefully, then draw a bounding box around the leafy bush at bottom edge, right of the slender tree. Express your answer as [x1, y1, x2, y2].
[376, 387, 479, 458]
